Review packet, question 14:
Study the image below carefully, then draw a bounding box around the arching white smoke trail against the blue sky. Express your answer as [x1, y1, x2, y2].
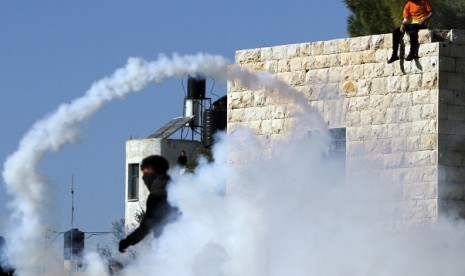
[3, 54, 228, 274]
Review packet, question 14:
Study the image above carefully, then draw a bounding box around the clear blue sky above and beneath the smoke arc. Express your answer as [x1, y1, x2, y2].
[0, 0, 349, 243]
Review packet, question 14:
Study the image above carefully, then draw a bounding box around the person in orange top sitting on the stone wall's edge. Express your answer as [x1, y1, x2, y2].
[388, 0, 433, 63]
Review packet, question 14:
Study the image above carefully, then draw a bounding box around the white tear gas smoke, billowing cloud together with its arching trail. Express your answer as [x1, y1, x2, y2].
[4, 53, 465, 276]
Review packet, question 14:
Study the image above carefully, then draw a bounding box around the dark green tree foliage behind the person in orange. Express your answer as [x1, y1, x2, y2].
[344, 0, 465, 37]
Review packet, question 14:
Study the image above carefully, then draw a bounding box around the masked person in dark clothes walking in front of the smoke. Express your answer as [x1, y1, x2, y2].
[118, 155, 176, 253]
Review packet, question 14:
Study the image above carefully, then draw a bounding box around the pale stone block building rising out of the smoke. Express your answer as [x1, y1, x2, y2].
[228, 30, 465, 223]
